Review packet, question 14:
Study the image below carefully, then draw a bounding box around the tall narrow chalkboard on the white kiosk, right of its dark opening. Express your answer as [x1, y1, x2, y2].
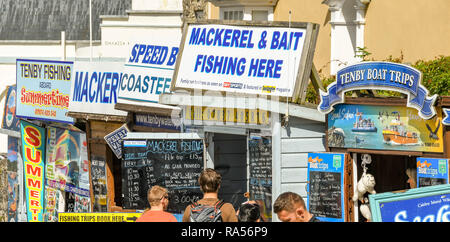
[248, 136, 272, 221]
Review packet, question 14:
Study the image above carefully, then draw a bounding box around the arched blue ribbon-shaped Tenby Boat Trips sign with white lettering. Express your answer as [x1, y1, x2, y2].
[317, 62, 437, 119]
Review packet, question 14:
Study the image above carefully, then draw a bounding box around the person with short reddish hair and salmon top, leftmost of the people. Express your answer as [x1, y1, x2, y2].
[136, 185, 177, 222]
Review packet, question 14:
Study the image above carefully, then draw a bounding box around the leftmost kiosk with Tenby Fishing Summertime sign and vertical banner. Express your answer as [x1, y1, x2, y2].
[2, 59, 90, 222]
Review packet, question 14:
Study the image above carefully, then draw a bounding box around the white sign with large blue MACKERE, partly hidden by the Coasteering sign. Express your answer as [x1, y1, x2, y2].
[69, 62, 127, 116]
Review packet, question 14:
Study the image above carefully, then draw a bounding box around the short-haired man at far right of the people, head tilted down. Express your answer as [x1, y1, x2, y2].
[273, 192, 320, 222]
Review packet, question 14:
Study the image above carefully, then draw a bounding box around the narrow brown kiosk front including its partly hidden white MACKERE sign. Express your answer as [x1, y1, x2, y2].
[68, 61, 128, 212]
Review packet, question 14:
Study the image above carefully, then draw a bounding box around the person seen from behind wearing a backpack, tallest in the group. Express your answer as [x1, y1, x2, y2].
[182, 168, 238, 222]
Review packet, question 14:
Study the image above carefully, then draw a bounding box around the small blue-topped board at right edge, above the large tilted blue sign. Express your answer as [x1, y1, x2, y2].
[417, 157, 449, 187]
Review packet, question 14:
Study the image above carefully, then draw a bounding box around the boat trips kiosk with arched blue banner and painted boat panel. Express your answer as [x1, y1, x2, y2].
[310, 62, 450, 222]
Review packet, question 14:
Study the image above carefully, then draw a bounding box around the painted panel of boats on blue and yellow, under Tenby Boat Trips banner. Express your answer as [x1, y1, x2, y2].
[328, 104, 443, 152]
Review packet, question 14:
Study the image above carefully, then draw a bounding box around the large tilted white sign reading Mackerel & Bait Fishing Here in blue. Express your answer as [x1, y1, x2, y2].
[174, 24, 306, 97]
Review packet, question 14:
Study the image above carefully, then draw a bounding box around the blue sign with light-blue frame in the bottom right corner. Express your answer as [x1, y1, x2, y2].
[369, 184, 450, 222]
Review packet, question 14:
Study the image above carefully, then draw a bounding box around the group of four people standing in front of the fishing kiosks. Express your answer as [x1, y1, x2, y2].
[136, 168, 319, 222]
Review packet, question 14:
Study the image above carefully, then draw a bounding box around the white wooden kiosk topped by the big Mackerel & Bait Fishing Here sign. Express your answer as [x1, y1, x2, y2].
[159, 18, 325, 221]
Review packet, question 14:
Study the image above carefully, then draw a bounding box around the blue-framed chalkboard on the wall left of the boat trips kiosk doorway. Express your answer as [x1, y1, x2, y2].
[307, 153, 345, 222]
